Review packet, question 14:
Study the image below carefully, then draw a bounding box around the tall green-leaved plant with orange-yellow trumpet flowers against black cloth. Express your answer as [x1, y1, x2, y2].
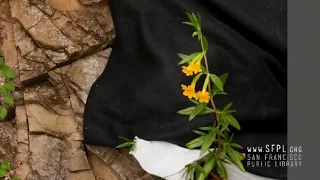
[178, 13, 245, 180]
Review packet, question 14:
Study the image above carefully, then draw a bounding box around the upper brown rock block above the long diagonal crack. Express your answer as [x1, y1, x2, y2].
[10, 0, 115, 84]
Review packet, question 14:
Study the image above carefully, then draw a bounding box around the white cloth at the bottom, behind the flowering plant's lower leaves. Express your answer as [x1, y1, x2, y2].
[129, 136, 274, 180]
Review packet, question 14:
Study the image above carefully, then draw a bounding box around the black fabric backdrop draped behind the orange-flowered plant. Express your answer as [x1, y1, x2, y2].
[84, 0, 287, 179]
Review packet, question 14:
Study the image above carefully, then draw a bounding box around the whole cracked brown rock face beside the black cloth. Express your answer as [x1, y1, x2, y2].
[0, 0, 152, 180]
